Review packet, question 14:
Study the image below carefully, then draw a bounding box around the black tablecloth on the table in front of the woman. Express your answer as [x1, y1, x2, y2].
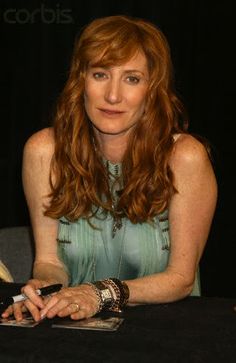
[0, 297, 236, 363]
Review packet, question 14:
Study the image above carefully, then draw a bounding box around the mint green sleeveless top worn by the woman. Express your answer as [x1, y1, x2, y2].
[58, 162, 200, 296]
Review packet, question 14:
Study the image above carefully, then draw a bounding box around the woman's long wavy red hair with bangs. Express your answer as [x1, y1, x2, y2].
[45, 16, 187, 223]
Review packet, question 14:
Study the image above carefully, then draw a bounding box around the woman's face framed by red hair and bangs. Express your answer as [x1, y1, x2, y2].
[85, 52, 148, 140]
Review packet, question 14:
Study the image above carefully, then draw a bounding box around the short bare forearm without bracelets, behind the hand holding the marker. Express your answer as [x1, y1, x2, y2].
[33, 261, 69, 286]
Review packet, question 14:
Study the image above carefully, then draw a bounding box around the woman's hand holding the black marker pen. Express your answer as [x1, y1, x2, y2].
[2, 279, 51, 321]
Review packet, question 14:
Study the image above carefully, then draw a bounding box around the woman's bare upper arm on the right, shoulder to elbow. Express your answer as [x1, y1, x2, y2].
[168, 135, 217, 285]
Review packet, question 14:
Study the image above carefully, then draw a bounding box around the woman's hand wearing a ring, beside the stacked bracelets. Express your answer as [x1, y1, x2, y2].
[40, 284, 99, 320]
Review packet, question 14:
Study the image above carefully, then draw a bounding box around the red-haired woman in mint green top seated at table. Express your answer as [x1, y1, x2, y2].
[1, 16, 217, 320]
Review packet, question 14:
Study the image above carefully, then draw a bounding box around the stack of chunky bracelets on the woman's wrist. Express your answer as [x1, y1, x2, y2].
[86, 278, 129, 312]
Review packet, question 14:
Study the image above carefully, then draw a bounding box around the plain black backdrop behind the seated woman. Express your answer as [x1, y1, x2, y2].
[0, 0, 236, 297]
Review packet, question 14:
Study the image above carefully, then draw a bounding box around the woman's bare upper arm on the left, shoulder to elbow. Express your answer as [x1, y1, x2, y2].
[22, 128, 60, 265]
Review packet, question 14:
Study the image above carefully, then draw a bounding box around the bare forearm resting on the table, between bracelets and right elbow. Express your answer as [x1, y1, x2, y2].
[125, 271, 193, 305]
